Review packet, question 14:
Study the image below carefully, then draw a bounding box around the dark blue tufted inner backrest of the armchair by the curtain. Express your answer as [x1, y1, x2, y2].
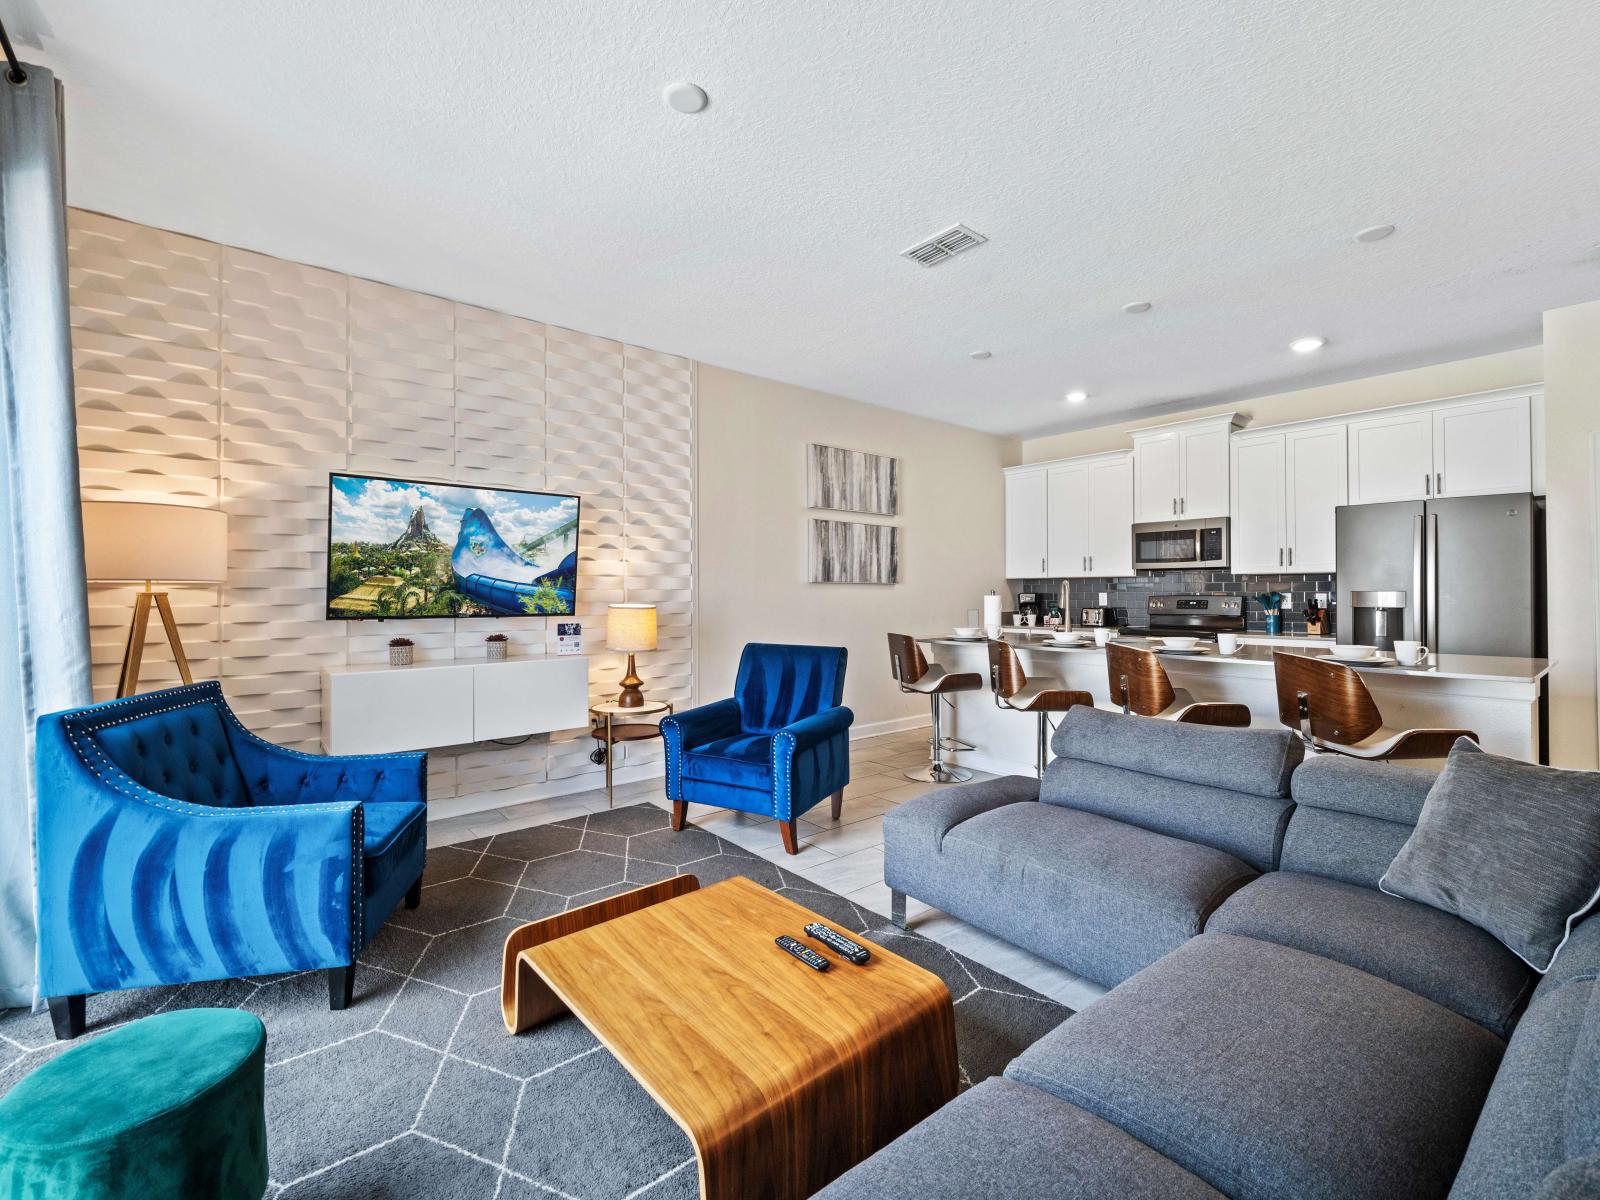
[83, 685, 250, 808]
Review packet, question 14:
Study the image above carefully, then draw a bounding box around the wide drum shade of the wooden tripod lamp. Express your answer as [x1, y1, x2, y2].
[83, 501, 227, 584]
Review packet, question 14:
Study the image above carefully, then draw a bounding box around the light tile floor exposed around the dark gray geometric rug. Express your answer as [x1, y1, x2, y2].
[427, 730, 1106, 1008]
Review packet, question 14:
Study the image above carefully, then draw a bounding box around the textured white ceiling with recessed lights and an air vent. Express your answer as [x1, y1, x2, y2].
[21, 0, 1600, 432]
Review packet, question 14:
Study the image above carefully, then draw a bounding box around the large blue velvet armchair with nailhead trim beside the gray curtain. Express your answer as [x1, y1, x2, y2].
[35, 682, 427, 1037]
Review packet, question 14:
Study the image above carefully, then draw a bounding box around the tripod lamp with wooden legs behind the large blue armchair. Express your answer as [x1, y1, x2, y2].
[83, 501, 227, 696]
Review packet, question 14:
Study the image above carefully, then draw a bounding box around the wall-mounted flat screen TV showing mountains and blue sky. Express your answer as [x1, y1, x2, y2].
[328, 472, 578, 621]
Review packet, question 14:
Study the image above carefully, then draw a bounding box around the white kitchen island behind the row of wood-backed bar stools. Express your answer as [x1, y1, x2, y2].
[918, 629, 1550, 774]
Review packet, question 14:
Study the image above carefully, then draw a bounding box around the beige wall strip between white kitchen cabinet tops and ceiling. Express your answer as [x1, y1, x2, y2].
[1022, 346, 1544, 462]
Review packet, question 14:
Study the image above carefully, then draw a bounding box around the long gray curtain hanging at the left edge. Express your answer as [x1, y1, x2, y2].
[0, 64, 90, 1008]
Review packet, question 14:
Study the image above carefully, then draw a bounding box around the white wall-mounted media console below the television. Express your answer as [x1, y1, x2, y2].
[322, 654, 589, 754]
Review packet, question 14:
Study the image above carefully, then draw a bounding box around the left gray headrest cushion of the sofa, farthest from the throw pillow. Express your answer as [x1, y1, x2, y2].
[1045, 704, 1306, 798]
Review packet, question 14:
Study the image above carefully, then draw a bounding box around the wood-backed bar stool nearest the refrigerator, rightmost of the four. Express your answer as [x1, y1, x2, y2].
[1272, 650, 1478, 762]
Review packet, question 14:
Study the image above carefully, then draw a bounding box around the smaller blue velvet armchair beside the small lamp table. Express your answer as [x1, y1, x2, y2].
[661, 642, 854, 854]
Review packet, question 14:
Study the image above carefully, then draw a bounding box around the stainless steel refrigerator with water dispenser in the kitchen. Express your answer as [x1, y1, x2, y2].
[1336, 493, 1544, 658]
